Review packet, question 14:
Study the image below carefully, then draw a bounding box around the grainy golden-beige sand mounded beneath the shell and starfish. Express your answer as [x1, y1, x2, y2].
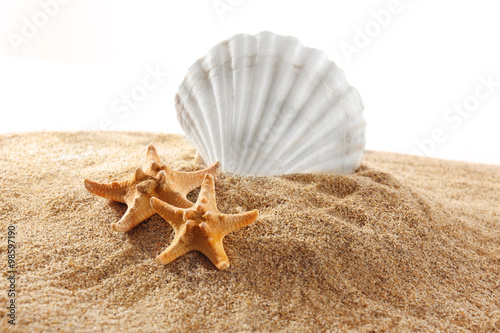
[0, 132, 500, 332]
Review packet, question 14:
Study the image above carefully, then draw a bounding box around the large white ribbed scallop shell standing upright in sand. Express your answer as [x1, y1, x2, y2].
[176, 32, 366, 175]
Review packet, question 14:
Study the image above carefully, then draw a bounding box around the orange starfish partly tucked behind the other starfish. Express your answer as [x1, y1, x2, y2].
[85, 145, 219, 232]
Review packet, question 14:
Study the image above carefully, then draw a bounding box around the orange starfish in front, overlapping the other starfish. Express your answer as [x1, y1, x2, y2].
[151, 174, 259, 269]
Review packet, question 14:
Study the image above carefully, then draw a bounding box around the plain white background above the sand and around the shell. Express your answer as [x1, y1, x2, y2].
[0, 0, 500, 164]
